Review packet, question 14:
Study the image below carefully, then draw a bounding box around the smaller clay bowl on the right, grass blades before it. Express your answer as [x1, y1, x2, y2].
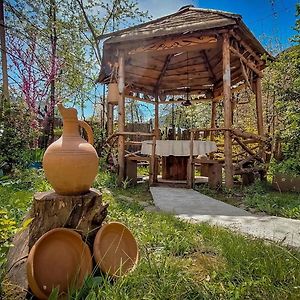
[93, 222, 138, 277]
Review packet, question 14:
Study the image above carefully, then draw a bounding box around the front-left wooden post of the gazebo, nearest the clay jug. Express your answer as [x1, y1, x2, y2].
[118, 52, 125, 185]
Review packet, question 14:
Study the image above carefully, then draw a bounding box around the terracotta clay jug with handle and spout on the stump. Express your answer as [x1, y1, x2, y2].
[43, 103, 99, 195]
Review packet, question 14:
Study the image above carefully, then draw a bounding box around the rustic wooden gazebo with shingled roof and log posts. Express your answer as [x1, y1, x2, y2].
[99, 6, 268, 188]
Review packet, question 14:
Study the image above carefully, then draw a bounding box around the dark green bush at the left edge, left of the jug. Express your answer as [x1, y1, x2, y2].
[0, 103, 38, 174]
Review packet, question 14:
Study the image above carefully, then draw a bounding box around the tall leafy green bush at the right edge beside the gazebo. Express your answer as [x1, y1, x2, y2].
[264, 11, 300, 175]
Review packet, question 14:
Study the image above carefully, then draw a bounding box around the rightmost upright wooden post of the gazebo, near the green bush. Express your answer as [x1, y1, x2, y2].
[254, 77, 266, 161]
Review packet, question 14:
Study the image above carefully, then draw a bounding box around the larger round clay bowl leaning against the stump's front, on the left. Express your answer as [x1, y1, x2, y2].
[27, 228, 93, 299]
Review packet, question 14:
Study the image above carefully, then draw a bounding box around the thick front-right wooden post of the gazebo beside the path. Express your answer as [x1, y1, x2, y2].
[223, 33, 233, 188]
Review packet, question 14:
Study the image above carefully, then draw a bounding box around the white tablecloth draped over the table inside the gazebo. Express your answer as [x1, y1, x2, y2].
[141, 140, 217, 156]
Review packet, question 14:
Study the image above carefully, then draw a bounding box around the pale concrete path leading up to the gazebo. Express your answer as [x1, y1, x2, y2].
[150, 187, 300, 248]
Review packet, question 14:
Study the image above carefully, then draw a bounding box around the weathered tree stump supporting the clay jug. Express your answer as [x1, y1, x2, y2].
[3, 189, 108, 300]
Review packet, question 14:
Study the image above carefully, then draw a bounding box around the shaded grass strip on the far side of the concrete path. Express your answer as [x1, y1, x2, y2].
[197, 181, 300, 219]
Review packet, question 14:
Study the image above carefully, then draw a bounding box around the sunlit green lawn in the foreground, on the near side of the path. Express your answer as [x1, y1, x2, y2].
[0, 173, 300, 300]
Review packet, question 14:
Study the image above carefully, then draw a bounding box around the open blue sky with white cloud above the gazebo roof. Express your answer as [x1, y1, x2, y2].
[137, 0, 299, 50]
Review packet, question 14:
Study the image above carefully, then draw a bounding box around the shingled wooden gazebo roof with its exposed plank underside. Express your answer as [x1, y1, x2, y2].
[99, 6, 269, 95]
